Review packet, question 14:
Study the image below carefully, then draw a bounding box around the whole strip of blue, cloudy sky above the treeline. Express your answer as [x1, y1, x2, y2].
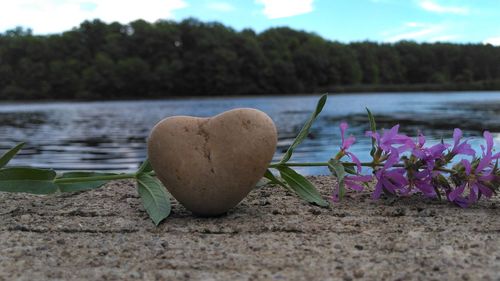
[0, 0, 500, 46]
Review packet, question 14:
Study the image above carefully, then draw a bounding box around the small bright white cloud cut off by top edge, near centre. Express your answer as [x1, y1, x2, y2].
[256, 0, 313, 19]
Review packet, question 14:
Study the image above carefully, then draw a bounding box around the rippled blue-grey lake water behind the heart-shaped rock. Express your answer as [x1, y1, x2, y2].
[0, 92, 500, 174]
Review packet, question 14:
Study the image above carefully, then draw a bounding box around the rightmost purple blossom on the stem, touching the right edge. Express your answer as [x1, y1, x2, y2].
[448, 131, 500, 207]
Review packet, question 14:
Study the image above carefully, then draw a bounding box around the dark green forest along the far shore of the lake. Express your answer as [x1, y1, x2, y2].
[0, 19, 500, 100]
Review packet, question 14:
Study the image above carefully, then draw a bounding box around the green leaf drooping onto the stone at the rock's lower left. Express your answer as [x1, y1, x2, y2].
[137, 174, 170, 225]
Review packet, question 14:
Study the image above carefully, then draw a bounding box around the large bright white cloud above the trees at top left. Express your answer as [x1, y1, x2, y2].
[0, 0, 187, 34]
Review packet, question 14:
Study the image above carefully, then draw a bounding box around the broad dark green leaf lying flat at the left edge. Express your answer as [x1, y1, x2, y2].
[0, 167, 58, 194]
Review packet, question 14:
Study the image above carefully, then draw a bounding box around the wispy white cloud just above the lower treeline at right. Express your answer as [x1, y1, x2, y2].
[382, 22, 458, 42]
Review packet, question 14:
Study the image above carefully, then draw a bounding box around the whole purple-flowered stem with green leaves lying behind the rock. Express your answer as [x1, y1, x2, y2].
[0, 95, 500, 224]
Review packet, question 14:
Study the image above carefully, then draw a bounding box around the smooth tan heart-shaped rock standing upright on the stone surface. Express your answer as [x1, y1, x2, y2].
[148, 108, 278, 216]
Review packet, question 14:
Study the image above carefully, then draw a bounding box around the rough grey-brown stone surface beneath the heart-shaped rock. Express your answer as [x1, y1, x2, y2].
[0, 177, 500, 280]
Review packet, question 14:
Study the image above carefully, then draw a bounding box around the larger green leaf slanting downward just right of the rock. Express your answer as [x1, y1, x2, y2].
[277, 166, 329, 207]
